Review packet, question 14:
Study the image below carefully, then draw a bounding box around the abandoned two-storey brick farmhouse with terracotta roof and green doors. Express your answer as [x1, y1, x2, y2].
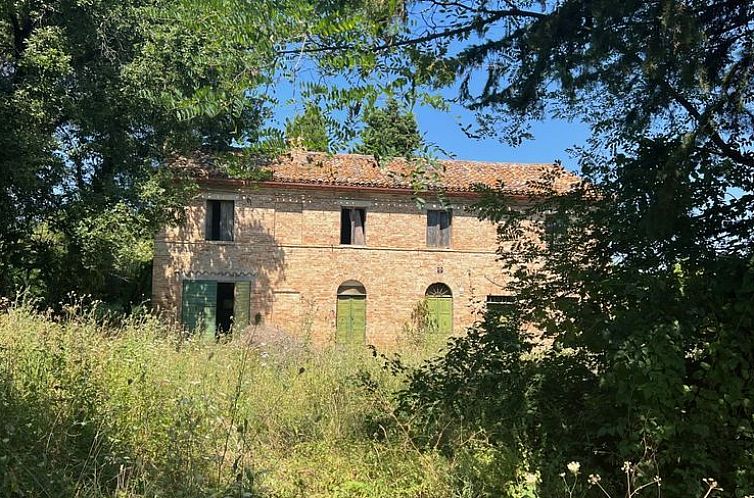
[153, 152, 576, 346]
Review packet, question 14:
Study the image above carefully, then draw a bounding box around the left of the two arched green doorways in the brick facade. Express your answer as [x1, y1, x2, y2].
[335, 280, 367, 344]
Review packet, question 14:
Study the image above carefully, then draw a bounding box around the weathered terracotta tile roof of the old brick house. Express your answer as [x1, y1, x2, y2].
[174, 152, 580, 195]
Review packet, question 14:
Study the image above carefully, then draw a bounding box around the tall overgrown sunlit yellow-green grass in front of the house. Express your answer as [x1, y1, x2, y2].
[0, 306, 458, 497]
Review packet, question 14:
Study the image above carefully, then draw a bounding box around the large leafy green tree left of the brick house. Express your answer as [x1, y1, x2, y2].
[0, 0, 304, 303]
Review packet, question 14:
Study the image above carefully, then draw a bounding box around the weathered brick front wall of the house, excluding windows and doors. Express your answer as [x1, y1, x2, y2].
[153, 183, 528, 345]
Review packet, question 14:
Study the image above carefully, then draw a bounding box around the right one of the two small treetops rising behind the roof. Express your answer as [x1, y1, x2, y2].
[354, 99, 422, 158]
